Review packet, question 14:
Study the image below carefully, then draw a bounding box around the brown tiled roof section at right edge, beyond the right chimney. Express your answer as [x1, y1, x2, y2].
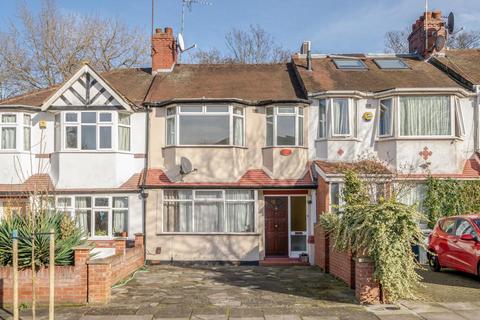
[435, 49, 480, 84]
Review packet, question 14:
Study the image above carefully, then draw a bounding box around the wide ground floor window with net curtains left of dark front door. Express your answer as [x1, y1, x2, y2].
[163, 190, 255, 233]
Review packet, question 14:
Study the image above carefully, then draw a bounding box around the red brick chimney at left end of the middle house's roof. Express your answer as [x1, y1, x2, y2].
[152, 27, 177, 74]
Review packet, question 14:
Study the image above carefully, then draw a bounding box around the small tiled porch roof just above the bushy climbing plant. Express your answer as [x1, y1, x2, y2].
[315, 160, 392, 175]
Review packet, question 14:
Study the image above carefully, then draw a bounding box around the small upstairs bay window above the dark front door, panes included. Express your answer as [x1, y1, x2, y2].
[266, 106, 303, 146]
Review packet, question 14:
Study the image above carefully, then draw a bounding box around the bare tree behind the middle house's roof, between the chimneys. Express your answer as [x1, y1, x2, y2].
[193, 25, 292, 64]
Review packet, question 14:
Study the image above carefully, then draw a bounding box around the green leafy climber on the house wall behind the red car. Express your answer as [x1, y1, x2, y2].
[424, 177, 480, 227]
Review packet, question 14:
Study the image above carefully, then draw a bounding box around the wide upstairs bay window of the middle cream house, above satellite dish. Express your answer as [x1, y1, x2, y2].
[166, 105, 245, 146]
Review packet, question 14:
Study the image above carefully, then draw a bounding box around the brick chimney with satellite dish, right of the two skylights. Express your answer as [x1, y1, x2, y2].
[408, 10, 447, 58]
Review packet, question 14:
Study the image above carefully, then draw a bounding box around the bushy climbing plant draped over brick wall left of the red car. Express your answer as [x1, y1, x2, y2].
[320, 171, 423, 302]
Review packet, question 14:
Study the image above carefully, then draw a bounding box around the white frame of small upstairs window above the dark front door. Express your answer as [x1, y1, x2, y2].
[265, 105, 305, 148]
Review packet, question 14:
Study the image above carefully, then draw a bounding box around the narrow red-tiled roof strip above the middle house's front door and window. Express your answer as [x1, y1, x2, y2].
[145, 169, 315, 189]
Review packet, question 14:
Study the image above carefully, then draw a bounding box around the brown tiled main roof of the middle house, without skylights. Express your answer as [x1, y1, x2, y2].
[147, 63, 306, 103]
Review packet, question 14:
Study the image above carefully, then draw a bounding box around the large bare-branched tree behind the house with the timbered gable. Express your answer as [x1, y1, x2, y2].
[0, 0, 149, 98]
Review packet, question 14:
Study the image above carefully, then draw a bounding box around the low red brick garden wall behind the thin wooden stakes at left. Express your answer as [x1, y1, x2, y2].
[0, 234, 144, 306]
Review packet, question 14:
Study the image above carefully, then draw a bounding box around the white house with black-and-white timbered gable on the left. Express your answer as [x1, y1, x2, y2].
[0, 63, 152, 251]
